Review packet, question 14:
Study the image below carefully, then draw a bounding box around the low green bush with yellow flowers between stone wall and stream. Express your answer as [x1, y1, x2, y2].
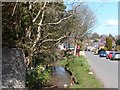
[26, 65, 50, 88]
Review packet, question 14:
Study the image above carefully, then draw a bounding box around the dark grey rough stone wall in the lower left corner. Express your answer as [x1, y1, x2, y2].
[2, 48, 26, 88]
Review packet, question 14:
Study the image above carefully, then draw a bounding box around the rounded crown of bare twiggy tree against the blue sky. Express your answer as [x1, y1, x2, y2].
[71, 4, 96, 39]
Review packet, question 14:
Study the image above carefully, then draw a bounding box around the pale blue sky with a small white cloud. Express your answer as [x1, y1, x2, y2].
[65, 0, 119, 36]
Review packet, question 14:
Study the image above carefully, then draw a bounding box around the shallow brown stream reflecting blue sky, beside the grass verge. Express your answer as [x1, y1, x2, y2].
[52, 64, 71, 88]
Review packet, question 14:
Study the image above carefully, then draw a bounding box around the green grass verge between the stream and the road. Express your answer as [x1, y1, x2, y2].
[60, 56, 103, 88]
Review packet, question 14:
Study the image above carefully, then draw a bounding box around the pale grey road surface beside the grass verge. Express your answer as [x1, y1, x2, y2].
[86, 52, 118, 88]
